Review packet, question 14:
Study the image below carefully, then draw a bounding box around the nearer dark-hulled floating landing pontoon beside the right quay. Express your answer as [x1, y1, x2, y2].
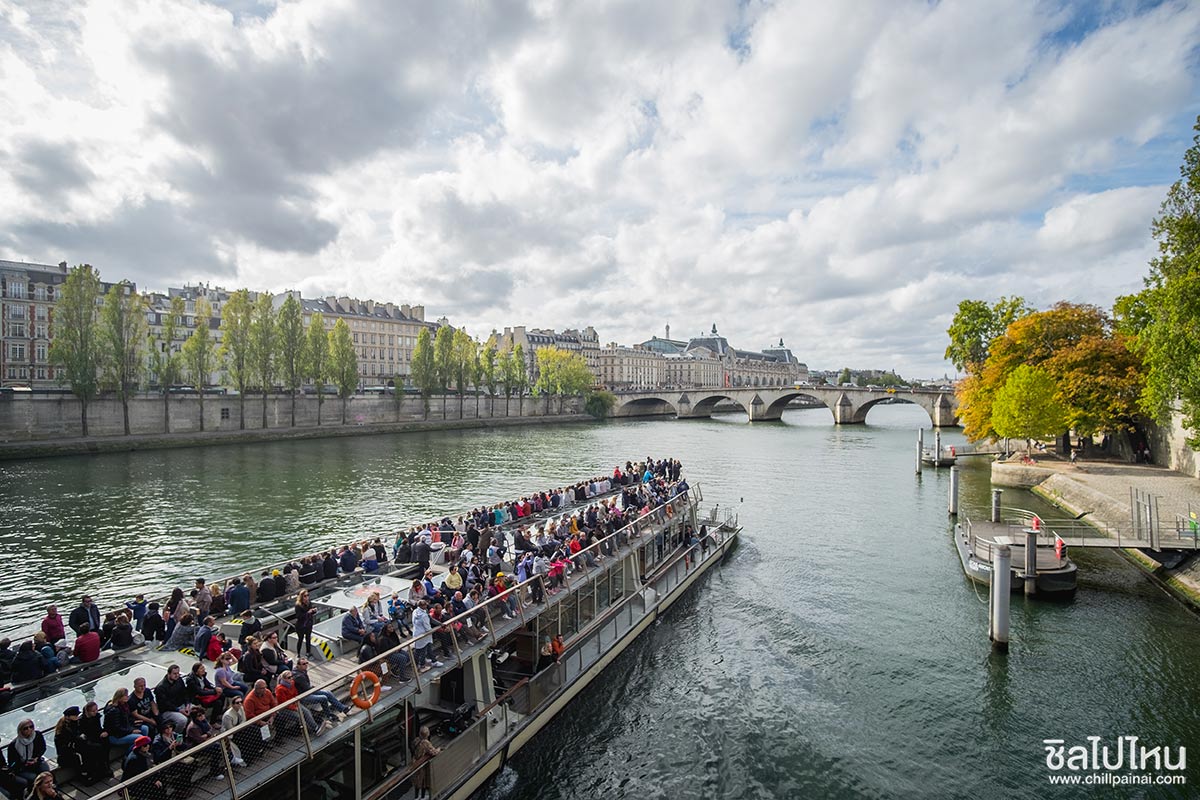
[954, 512, 1076, 596]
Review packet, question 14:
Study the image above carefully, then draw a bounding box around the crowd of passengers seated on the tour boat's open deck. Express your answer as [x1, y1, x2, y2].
[0, 458, 707, 799]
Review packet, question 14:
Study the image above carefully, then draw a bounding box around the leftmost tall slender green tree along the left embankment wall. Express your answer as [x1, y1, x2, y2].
[49, 264, 102, 437]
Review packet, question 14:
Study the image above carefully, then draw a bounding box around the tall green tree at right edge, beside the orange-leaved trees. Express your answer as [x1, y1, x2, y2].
[1123, 118, 1200, 449]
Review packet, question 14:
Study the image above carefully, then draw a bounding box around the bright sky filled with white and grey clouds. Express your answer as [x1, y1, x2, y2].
[0, 0, 1200, 378]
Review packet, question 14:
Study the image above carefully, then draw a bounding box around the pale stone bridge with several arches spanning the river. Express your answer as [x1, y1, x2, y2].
[612, 385, 959, 428]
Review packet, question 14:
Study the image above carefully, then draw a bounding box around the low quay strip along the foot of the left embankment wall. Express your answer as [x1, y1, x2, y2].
[0, 414, 595, 461]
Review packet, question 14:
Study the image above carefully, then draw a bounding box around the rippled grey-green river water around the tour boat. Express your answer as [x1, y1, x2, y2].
[0, 405, 1200, 800]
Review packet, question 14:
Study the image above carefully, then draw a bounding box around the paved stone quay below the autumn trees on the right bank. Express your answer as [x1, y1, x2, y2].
[991, 461, 1200, 612]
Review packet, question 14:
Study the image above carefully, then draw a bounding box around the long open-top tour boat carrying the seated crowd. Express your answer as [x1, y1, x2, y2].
[0, 474, 740, 800]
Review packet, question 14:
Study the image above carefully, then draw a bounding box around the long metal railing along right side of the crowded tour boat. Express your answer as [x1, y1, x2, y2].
[92, 489, 700, 800]
